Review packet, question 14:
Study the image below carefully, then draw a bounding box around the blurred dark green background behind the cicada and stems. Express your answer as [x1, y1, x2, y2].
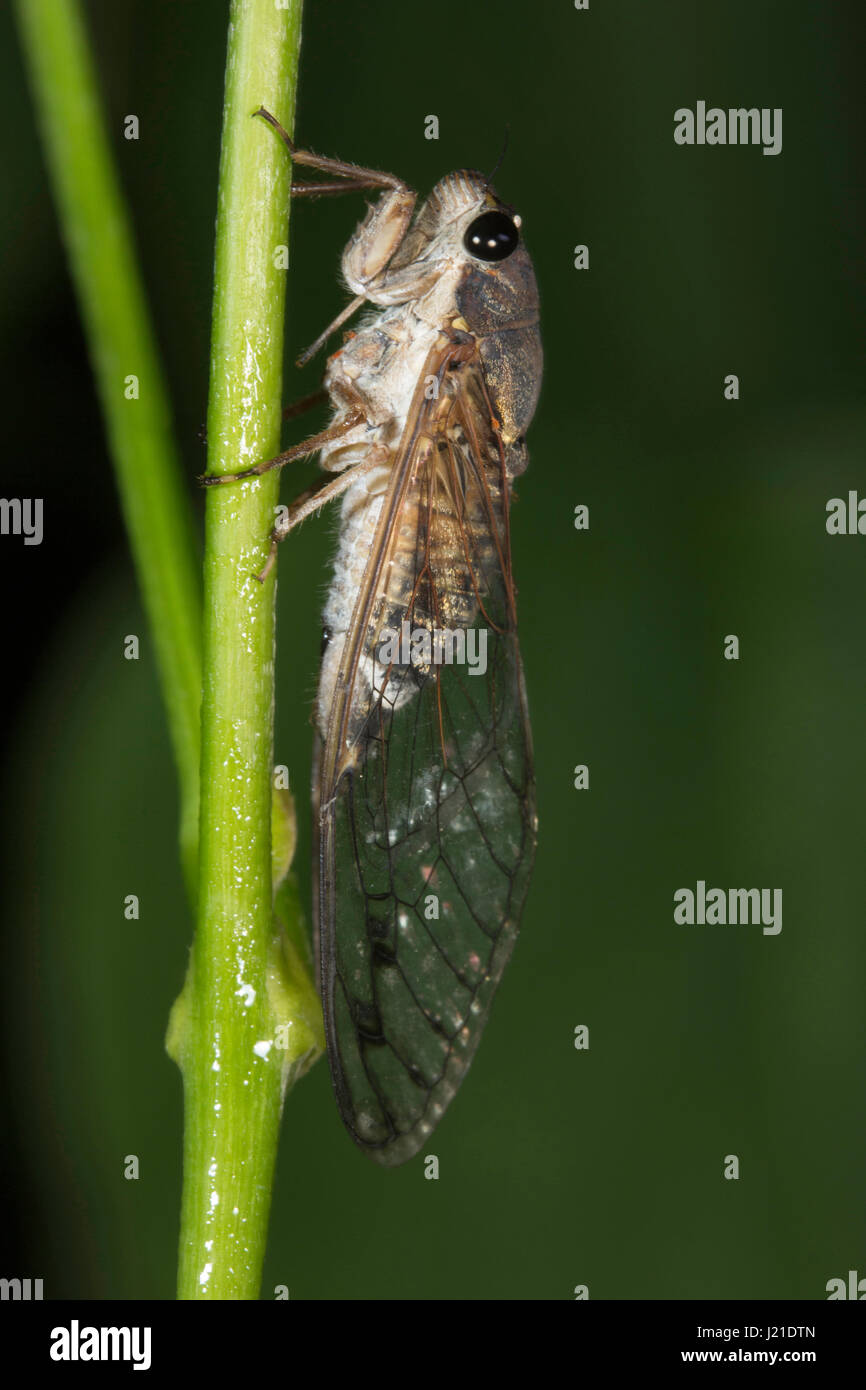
[0, 0, 866, 1300]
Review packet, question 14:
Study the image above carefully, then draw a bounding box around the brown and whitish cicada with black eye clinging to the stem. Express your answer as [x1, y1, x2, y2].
[206, 108, 542, 1165]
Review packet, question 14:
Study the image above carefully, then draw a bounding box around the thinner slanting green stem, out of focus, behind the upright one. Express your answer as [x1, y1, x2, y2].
[15, 0, 202, 899]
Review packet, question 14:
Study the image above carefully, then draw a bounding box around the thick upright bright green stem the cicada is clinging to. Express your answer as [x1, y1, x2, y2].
[175, 0, 306, 1298]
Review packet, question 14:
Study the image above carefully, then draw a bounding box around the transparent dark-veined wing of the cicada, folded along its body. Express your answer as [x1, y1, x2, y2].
[318, 344, 535, 1163]
